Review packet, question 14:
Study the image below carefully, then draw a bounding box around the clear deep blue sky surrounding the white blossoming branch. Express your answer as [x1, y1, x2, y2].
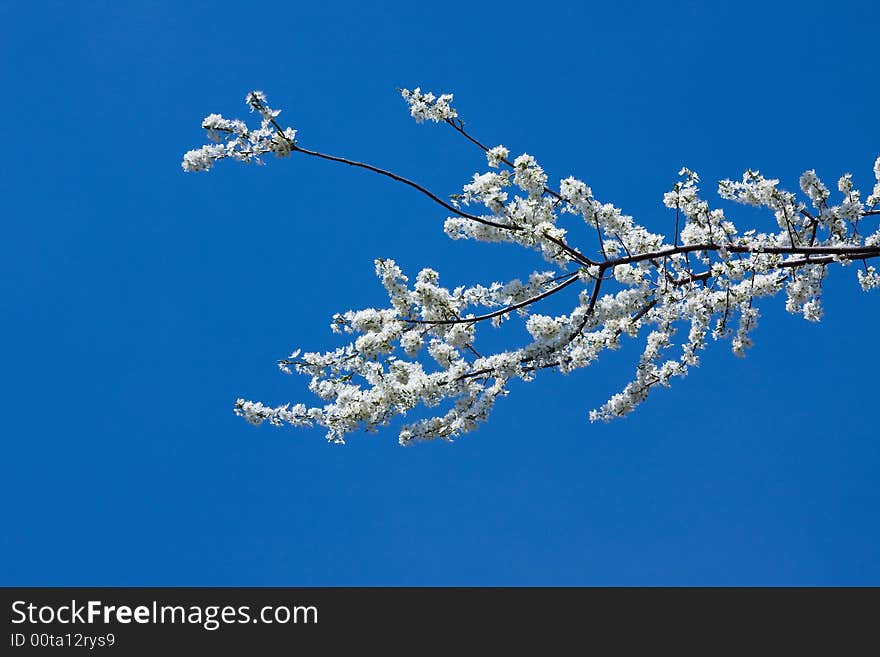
[0, 1, 880, 585]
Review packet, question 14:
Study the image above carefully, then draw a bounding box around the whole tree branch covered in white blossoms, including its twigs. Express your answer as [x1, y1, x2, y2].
[183, 88, 880, 444]
